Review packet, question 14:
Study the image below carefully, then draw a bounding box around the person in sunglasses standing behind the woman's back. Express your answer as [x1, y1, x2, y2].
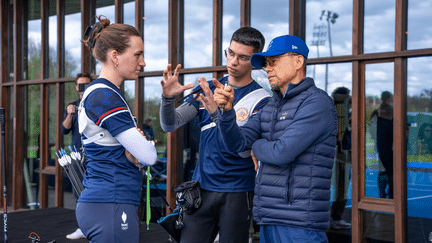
[60, 73, 92, 240]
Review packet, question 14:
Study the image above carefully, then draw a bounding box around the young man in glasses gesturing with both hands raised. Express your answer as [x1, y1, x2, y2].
[160, 27, 269, 243]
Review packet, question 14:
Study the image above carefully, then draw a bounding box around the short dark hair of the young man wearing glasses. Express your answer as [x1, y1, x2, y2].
[231, 27, 265, 53]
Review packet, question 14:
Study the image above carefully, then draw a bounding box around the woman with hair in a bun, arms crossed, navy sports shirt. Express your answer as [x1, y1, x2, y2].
[76, 16, 157, 243]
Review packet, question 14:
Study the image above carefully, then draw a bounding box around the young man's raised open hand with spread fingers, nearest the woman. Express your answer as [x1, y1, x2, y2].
[161, 64, 193, 98]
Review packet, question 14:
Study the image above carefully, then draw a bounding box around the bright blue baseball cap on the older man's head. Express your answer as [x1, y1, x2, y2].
[251, 35, 309, 68]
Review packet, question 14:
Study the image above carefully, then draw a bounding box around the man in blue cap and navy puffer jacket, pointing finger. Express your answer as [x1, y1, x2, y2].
[214, 35, 337, 243]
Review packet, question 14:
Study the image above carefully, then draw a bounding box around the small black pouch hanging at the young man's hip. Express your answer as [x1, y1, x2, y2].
[174, 181, 202, 214]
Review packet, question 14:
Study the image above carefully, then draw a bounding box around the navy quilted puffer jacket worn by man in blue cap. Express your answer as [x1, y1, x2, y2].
[218, 78, 337, 230]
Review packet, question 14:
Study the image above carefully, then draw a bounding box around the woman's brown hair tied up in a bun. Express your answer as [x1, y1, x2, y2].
[84, 15, 140, 62]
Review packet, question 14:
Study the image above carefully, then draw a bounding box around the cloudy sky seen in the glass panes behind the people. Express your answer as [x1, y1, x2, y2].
[29, 0, 432, 98]
